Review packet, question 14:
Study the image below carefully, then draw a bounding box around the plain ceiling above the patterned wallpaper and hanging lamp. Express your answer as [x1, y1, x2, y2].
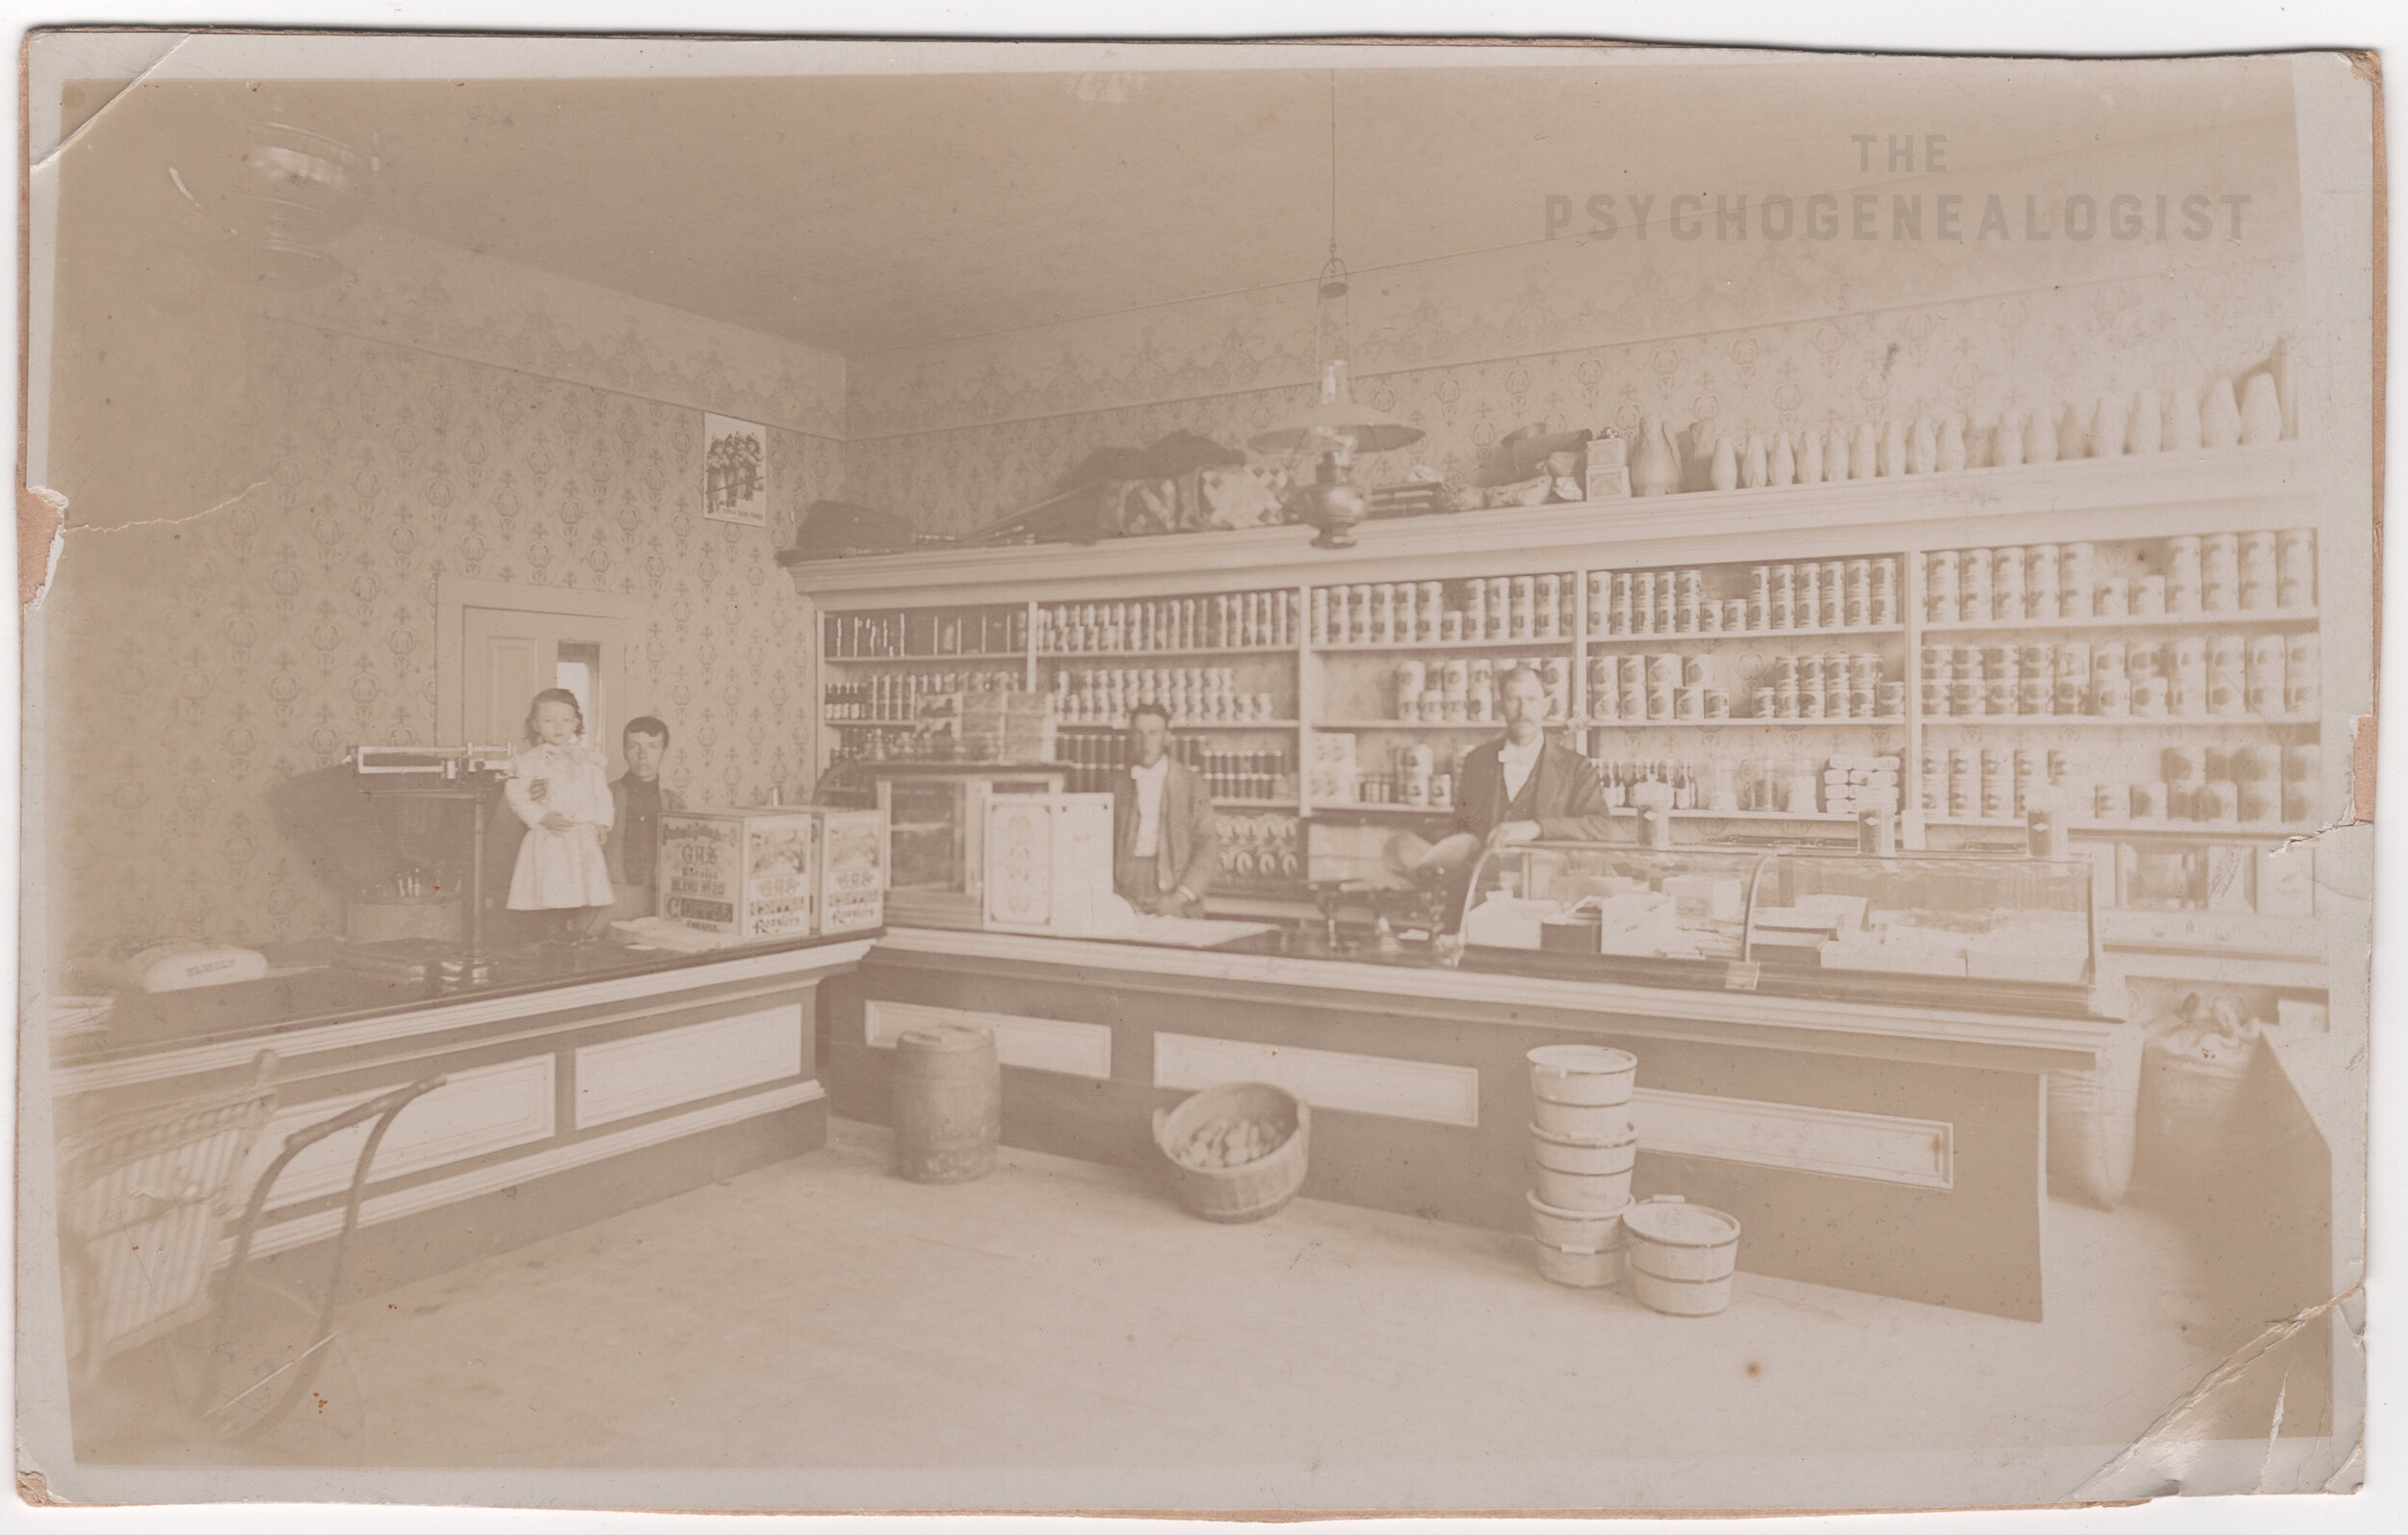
[70, 53, 2290, 356]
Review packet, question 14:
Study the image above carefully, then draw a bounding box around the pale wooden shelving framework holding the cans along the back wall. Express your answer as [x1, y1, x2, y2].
[793, 443, 2348, 981]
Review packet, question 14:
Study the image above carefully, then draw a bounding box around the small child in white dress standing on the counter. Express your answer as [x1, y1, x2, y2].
[504, 689, 615, 938]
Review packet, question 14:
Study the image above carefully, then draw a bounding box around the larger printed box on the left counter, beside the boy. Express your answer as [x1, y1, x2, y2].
[660, 811, 819, 938]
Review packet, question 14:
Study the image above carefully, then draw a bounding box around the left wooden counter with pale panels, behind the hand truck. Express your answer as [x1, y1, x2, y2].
[51, 933, 872, 1288]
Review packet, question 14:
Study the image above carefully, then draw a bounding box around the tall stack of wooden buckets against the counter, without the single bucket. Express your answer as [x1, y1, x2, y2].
[1530, 1044, 1640, 1288]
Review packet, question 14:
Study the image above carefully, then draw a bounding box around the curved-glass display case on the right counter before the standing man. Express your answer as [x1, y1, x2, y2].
[1462, 842, 2103, 1013]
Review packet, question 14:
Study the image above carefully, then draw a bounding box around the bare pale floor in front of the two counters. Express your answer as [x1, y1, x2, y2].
[160, 1121, 2297, 1509]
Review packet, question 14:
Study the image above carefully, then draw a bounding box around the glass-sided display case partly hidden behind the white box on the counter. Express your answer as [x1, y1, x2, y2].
[862, 763, 1069, 928]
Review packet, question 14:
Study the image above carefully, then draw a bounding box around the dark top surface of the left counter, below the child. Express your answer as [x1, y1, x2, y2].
[53, 928, 881, 1068]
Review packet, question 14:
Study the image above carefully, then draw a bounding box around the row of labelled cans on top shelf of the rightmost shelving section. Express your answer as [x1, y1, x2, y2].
[1924, 527, 2316, 623]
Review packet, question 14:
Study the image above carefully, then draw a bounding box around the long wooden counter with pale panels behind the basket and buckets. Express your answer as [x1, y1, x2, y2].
[822, 928, 2124, 1318]
